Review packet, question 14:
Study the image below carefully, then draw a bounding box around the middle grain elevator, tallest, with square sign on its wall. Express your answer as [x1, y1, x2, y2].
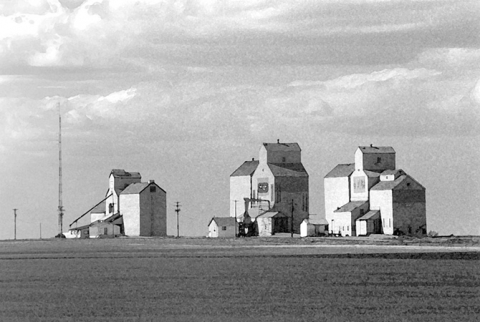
[230, 141, 309, 236]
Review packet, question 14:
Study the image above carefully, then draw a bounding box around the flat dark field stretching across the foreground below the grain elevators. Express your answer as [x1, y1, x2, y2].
[0, 238, 480, 321]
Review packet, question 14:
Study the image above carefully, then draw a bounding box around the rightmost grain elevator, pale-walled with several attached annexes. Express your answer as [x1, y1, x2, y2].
[324, 145, 426, 236]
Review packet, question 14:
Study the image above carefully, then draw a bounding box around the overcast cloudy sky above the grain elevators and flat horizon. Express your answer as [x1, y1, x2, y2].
[0, 0, 480, 239]
